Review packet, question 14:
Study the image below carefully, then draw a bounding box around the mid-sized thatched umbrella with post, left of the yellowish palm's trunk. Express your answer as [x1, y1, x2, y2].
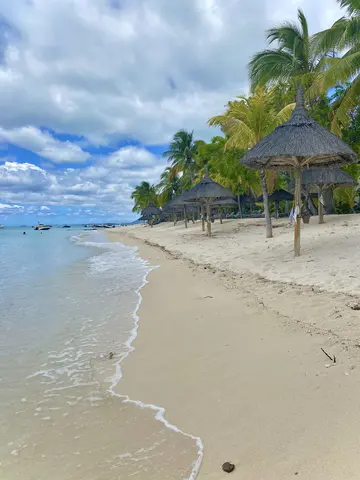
[183, 172, 233, 237]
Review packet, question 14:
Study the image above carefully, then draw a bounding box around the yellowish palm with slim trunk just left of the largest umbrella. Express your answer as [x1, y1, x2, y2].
[209, 87, 294, 238]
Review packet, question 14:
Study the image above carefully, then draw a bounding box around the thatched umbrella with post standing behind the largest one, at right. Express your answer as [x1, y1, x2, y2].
[292, 168, 357, 223]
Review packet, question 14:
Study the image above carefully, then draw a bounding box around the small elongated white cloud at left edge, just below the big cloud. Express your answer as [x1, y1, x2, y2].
[0, 127, 90, 163]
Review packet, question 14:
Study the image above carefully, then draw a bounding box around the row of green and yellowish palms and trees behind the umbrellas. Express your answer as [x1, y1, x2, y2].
[131, 0, 360, 214]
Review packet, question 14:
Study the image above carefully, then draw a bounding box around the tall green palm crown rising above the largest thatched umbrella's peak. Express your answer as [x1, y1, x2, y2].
[249, 9, 323, 87]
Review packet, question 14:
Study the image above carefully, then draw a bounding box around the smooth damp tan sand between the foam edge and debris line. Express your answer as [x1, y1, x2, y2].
[106, 223, 360, 480]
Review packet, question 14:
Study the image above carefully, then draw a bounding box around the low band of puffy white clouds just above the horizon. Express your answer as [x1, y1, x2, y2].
[0, 147, 165, 214]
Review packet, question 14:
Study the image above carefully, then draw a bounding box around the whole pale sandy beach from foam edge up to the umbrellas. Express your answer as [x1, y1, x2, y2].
[109, 215, 360, 480]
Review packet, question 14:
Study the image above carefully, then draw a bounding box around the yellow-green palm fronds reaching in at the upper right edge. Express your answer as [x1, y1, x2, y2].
[312, 0, 360, 135]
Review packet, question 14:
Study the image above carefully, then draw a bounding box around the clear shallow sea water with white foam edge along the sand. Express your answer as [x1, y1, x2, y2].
[0, 228, 201, 480]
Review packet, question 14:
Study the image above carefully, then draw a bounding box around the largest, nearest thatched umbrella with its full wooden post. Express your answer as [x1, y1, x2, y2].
[241, 86, 357, 256]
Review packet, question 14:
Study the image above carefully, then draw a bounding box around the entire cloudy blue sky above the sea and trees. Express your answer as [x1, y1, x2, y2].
[0, 0, 343, 225]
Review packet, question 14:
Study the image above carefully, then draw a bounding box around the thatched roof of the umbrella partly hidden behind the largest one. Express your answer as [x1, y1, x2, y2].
[301, 168, 357, 187]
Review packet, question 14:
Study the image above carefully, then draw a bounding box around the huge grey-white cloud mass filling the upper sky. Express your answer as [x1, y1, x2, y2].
[0, 0, 340, 143]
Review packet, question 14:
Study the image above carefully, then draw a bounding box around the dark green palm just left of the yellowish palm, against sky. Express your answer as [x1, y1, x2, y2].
[163, 130, 196, 183]
